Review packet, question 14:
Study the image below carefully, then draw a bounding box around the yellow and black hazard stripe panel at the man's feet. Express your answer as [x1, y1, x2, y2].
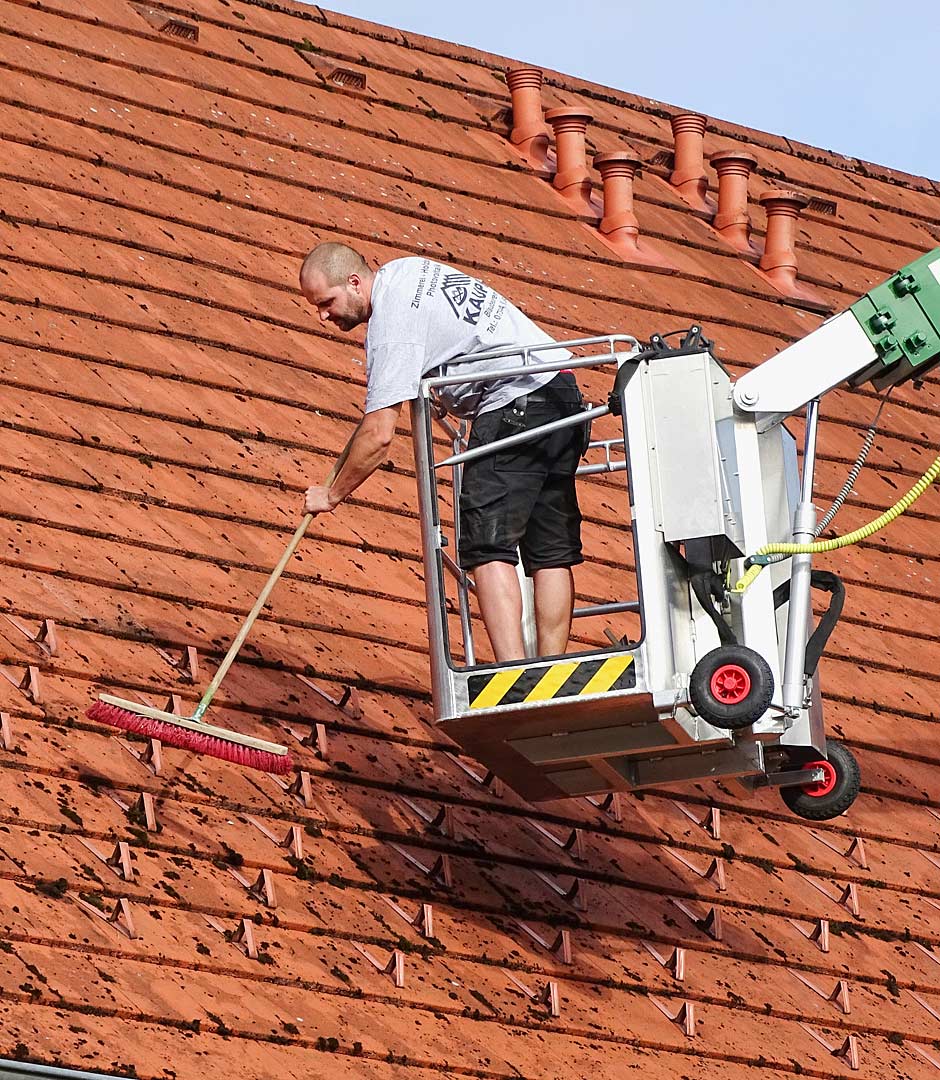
[467, 656, 636, 708]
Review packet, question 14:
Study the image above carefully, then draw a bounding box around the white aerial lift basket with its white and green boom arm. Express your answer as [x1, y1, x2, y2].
[412, 249, 940, 819]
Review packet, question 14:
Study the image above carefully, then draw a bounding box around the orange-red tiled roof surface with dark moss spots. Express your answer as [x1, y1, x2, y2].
[0, 0, 940, 1080]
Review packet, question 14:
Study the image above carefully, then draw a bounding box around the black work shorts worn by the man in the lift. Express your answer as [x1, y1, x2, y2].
[458, 372, 585, 576]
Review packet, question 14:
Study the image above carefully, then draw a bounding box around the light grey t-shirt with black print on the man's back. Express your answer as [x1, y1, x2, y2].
[365, 256, 572, 417]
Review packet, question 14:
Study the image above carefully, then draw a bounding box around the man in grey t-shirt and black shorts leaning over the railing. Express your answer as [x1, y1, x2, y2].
[300, 243, 583, 662]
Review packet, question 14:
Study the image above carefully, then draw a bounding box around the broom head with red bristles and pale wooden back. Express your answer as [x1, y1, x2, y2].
[85, 693, 294, 774]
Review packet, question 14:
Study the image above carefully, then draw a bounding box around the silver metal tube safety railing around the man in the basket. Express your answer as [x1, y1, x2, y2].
[415, 334, 641, 666]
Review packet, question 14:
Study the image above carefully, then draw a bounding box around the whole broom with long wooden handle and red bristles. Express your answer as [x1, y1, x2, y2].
[85, 438, 352, 774]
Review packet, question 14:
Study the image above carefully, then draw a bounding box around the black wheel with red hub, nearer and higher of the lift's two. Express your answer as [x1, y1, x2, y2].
[688, 645, 774, 730]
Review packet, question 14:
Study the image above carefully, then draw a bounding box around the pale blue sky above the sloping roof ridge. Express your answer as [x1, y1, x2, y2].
[311, 0, 940, 180]
